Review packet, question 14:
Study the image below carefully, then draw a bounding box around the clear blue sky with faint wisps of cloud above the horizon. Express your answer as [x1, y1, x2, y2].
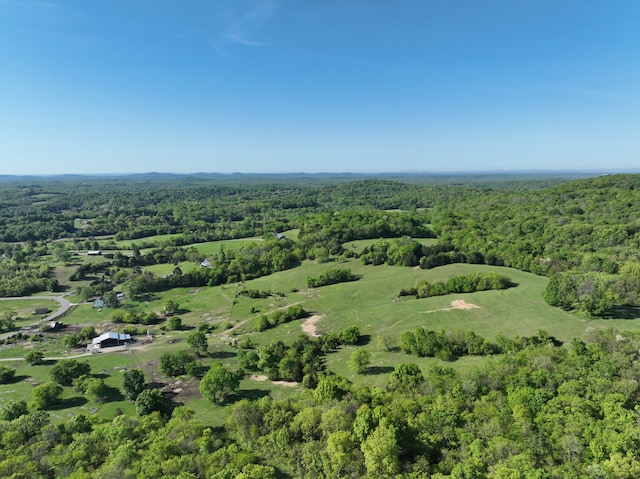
[0, 0, 640, 174]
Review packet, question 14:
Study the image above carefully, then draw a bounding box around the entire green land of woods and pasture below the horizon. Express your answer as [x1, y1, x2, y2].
[0, 175, 640, 479]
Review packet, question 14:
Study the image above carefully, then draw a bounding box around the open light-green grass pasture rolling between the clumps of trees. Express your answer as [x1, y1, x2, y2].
[5, 256, 640, 425]
